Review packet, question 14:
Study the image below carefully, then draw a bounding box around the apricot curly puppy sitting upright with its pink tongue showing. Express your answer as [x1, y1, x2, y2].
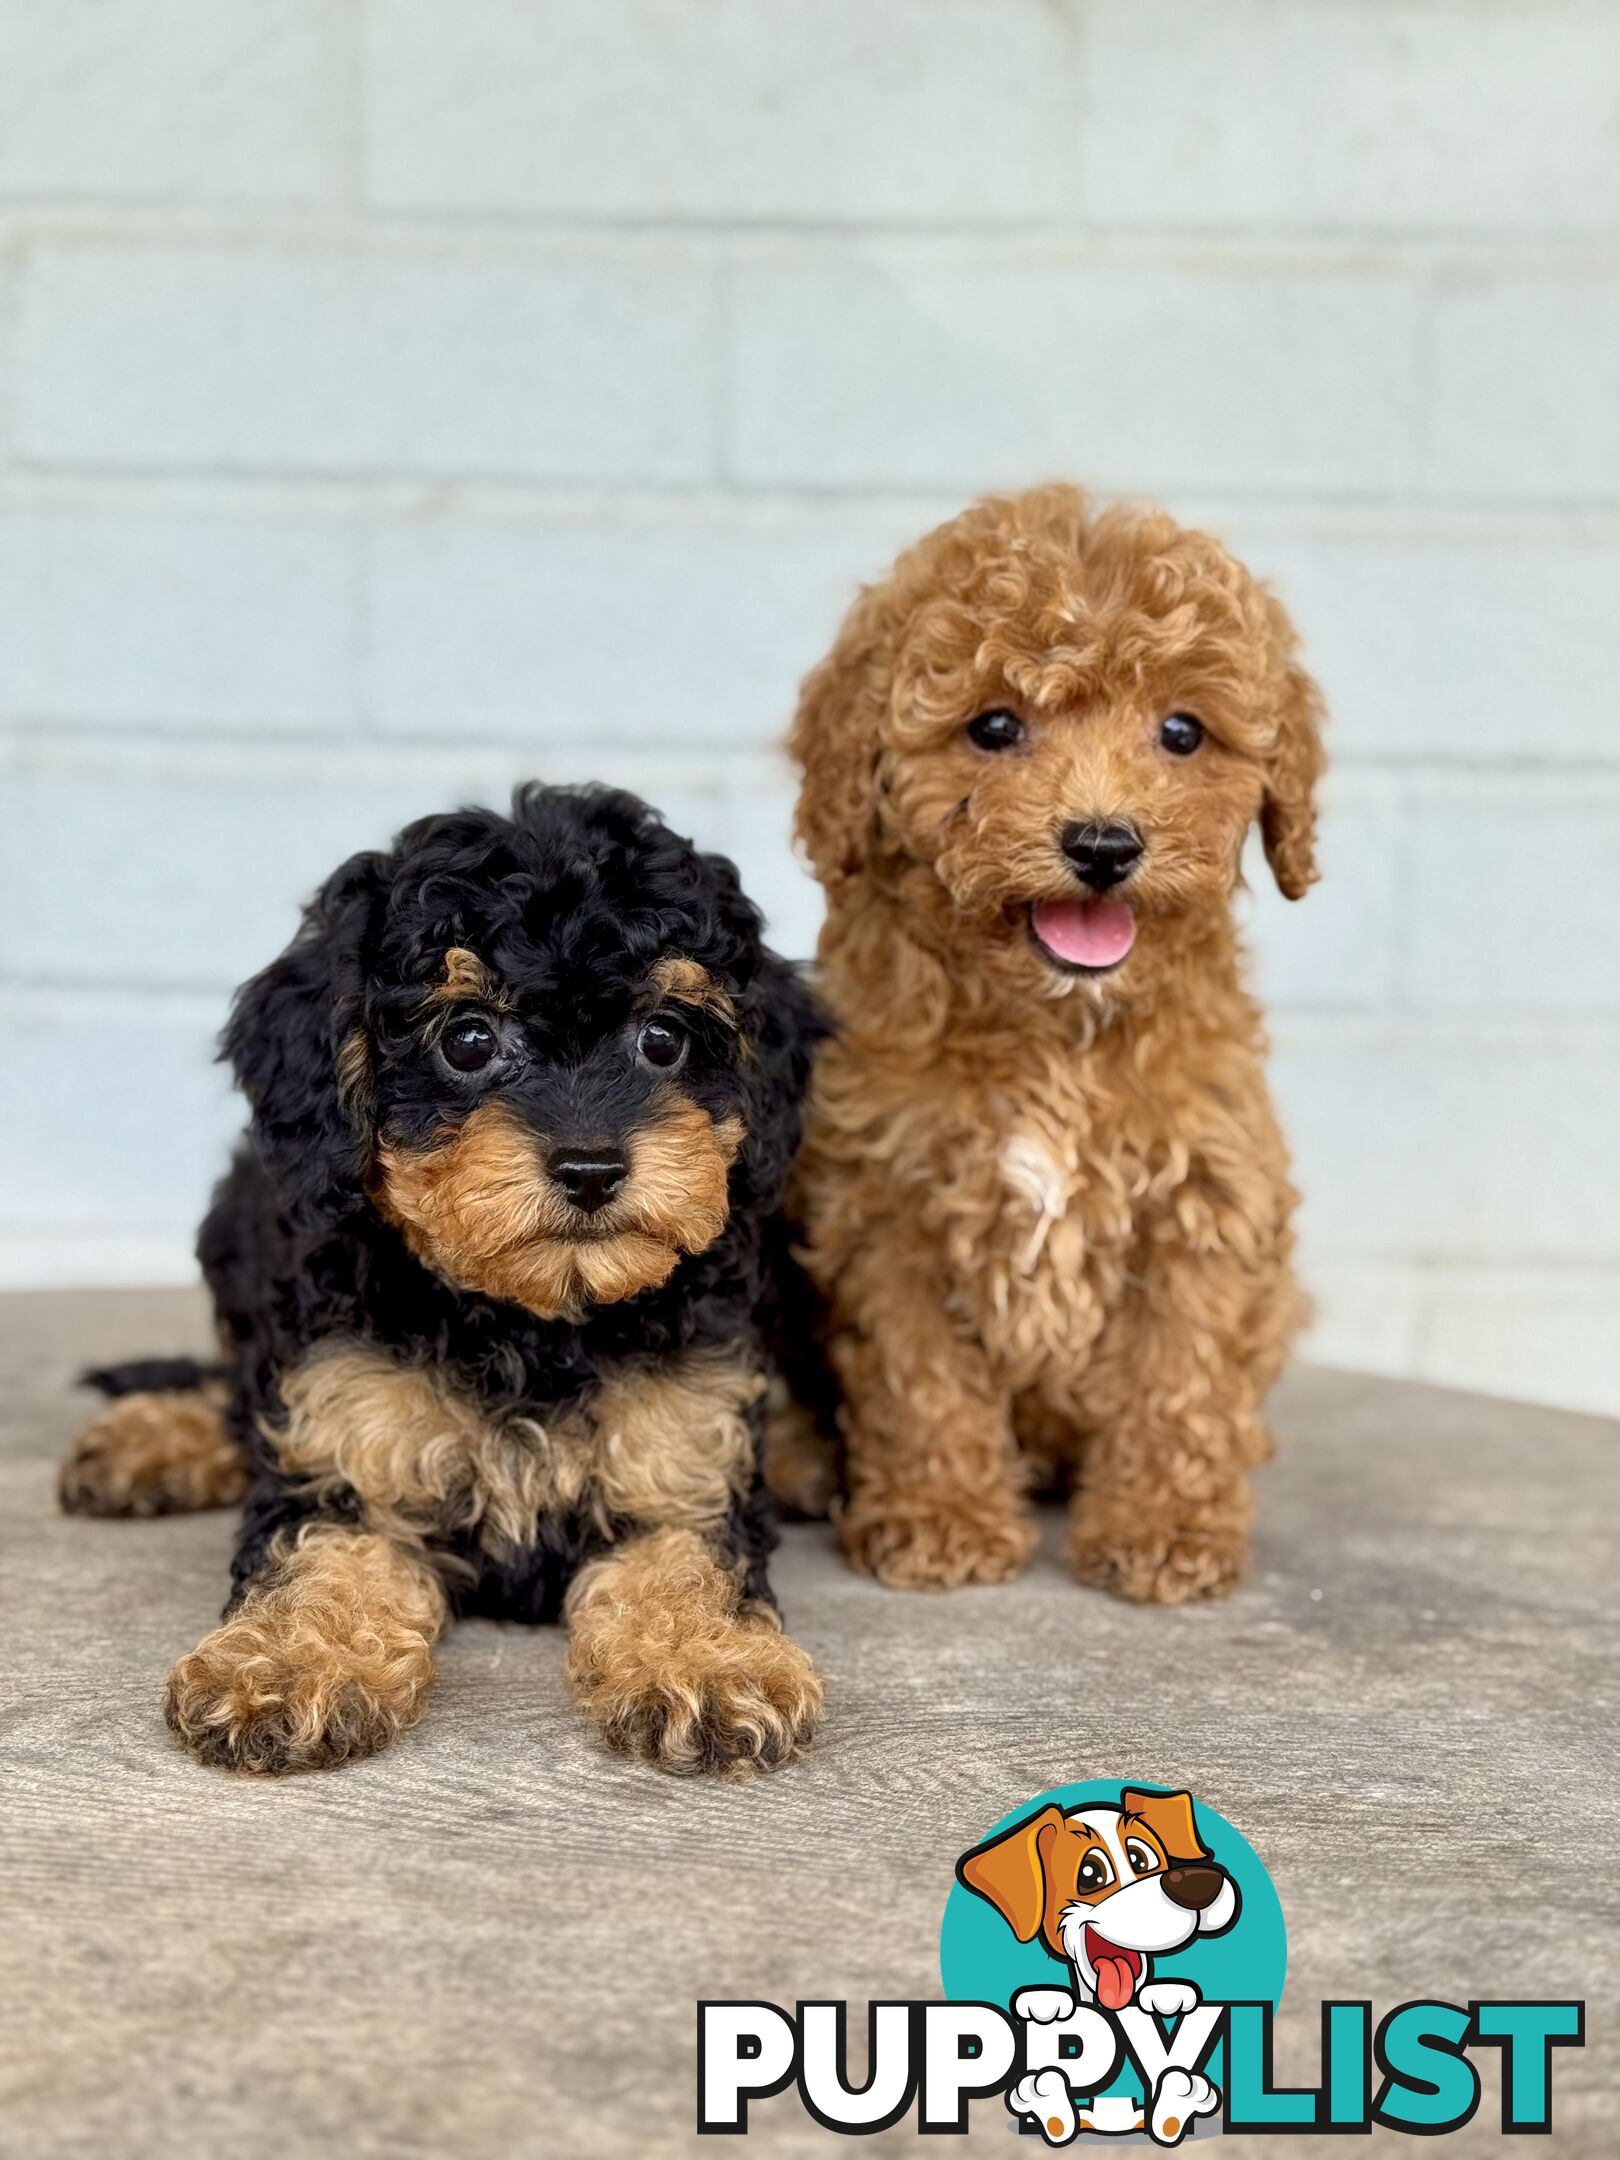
[793, 486, 1322, 1605]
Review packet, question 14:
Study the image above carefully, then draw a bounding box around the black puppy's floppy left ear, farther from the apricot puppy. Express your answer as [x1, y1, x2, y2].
[220, 855, 387, 1227]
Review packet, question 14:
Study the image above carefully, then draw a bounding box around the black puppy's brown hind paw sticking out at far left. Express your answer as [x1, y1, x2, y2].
[56, 1389, 248, 1516]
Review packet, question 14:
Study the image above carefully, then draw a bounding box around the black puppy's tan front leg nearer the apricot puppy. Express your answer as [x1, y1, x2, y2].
[568, 1529, 821, 1776]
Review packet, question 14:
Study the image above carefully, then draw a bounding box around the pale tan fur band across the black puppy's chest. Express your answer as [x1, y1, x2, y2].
[268, 1344, 765, 1553]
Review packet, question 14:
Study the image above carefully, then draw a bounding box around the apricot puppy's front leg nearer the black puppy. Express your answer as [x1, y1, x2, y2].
[829, 1242, 1035, 1590]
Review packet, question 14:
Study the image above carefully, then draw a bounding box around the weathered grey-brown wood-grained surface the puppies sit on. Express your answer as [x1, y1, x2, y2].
[0, 1292, 1620, 2160]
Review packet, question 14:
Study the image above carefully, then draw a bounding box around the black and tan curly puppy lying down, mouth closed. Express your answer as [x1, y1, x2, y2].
[63, 786, 821, 1771]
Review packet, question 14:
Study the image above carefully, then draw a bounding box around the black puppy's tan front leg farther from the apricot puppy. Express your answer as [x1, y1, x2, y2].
[164, 1525, 447, 1771]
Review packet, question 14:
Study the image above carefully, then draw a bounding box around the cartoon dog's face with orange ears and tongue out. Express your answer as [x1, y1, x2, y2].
[957, 1786, 1238, 2011]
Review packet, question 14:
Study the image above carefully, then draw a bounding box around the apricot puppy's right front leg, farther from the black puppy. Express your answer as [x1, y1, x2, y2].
[1069, 1248, 1270, 1605]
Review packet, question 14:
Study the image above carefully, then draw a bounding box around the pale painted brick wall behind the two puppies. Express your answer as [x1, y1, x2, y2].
[0, 0, 1620, 1408]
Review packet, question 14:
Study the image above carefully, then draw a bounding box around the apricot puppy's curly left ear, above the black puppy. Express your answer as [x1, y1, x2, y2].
[788, 585, 892, 888]
